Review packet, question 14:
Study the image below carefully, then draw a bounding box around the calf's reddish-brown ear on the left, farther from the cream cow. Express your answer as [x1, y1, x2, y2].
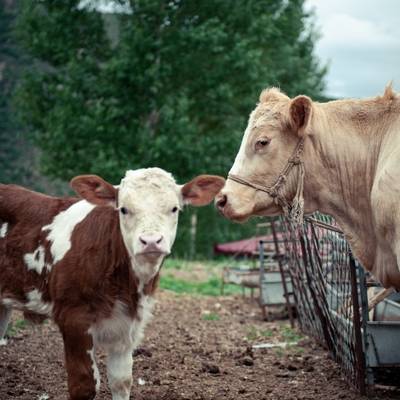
[70, 175, 118, 206]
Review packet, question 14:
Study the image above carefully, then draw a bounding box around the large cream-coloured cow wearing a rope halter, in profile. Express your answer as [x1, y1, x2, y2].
[216, 86, 400, 289]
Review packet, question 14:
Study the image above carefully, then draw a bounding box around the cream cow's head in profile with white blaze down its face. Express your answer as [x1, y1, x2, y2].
[216, 89, 312, 221]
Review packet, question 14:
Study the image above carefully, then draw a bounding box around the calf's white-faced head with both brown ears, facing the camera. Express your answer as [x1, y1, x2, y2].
[71, 168, 225, 279]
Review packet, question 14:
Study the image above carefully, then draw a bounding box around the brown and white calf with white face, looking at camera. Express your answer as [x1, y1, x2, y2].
[0, 168, 224, 400]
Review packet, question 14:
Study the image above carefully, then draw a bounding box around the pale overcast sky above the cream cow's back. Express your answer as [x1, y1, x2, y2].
[307, 0, 400, 97]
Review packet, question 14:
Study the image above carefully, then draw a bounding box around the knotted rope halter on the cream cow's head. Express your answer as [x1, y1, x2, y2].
[228, 138, 304, 224]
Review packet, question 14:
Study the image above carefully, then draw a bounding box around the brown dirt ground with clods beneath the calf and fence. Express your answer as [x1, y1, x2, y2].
[0, 291, 400, 400]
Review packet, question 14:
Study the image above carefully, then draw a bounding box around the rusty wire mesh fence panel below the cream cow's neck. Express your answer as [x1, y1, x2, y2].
[275, 214, 366, 393]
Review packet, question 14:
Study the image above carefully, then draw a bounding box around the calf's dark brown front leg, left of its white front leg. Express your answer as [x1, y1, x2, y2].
[60, 313, 100, 400]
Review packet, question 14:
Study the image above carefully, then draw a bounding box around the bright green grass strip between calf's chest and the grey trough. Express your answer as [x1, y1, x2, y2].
[160, 274, 241, 296]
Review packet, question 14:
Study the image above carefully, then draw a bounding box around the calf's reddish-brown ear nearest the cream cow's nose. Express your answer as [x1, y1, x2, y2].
[181, 175, 225, 207]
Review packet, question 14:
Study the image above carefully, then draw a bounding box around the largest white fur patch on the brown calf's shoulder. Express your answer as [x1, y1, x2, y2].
[42, 200, 95, 264]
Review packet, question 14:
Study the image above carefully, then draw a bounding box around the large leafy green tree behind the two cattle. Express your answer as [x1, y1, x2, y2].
[16, 0, 325, 254]
